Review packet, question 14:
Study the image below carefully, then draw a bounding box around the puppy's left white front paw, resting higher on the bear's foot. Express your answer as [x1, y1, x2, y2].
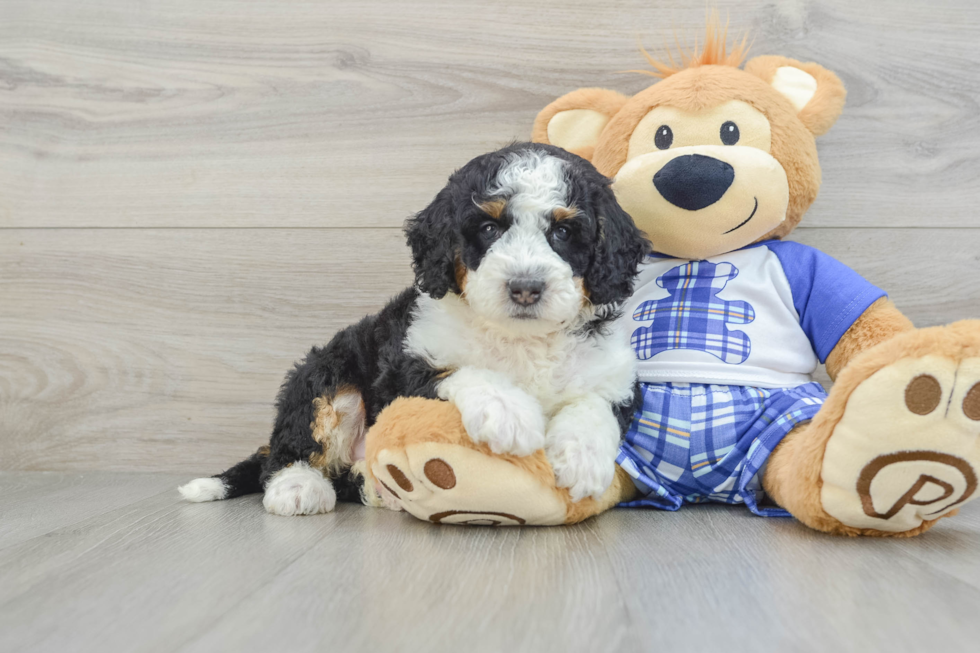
[454, 387, 545, 456]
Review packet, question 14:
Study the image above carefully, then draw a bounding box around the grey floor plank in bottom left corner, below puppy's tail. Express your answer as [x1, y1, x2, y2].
[0, 488, 345, 651]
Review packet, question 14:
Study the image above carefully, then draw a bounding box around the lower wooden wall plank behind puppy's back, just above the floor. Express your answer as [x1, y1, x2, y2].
[0, 229, 980, 474]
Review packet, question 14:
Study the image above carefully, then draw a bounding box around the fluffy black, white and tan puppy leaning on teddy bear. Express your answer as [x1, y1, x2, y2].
[180, 144, 648, 515]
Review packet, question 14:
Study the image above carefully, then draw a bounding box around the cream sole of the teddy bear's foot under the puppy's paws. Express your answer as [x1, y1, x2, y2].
[371, 442, 566, 526]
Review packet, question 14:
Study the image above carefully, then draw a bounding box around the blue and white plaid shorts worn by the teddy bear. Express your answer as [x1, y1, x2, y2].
[616, 383, 827, 517]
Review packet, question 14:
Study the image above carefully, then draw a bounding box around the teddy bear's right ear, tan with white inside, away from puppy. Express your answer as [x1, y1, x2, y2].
[745, 56, 847, 136]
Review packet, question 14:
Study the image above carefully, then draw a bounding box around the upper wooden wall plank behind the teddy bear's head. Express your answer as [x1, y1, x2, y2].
[0, 0, 980, 228]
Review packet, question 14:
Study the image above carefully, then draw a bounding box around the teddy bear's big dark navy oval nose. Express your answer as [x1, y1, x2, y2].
[653, 154, 735, 211]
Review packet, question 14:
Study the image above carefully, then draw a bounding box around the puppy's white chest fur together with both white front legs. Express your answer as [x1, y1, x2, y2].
[406, 295, 636, 484]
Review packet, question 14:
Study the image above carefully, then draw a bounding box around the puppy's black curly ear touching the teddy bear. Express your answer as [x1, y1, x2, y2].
[585, 182, 650, 306]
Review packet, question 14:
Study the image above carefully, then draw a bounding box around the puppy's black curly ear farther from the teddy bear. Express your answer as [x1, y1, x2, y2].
[405, 188, 460, 299]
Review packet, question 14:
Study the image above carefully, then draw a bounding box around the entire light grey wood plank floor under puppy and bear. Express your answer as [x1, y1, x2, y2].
[0, 472, 980, 653]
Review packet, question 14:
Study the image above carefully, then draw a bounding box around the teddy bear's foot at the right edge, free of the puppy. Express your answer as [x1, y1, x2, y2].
[813, 322, 980, 534]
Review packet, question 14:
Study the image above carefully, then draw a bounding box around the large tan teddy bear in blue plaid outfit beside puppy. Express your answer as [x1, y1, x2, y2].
[366, 23, 980, 536]
